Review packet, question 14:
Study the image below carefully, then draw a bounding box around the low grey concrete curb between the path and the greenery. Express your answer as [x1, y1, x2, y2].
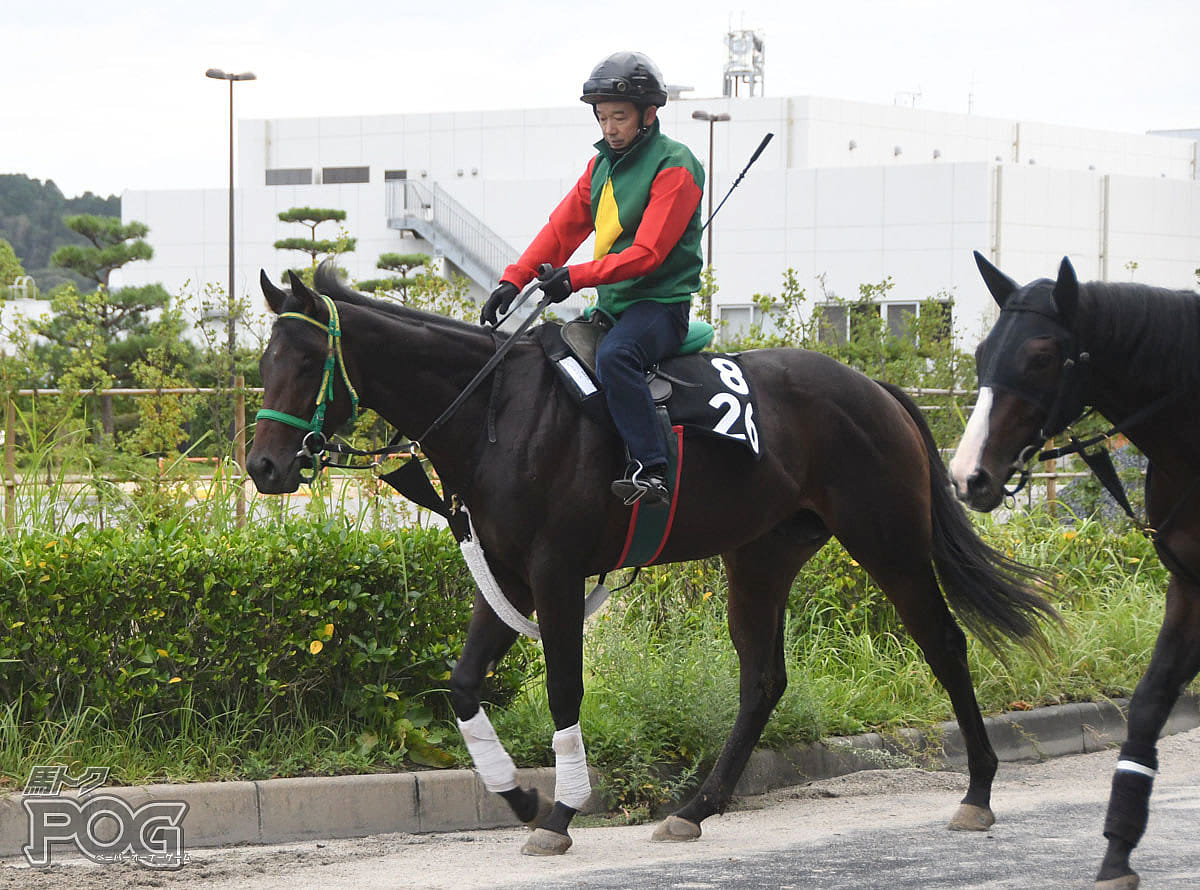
[0, 694, 1200, 858]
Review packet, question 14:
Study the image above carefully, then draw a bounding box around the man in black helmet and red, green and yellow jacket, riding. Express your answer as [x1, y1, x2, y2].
[480, 53, 704, 505]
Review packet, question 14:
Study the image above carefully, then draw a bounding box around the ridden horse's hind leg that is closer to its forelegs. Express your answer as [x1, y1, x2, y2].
[654, 528, 824, 841]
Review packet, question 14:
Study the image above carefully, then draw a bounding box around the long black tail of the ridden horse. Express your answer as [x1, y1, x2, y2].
[878, 381, 1061, 654]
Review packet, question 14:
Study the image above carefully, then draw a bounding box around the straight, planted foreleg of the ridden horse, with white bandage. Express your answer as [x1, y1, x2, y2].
[521, 567, 592, 856]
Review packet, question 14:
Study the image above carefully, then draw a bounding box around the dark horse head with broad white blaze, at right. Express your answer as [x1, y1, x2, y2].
[950, 252, 1086, 511]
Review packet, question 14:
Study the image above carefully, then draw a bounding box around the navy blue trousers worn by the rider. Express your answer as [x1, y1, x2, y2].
[596, 300, 691, 467]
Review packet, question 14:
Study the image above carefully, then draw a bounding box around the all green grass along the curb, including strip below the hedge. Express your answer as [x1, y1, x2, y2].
[0, 460, 1166, 818]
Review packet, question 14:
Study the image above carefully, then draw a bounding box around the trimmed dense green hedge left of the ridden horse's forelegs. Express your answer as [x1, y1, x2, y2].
[0, 519, 524, 734]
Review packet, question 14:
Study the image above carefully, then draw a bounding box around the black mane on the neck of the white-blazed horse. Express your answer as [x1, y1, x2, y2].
[1076, 281, 1200, 389]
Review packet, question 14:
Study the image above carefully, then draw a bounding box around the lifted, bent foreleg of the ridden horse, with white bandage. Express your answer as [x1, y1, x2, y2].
[450, 593, 550, 828]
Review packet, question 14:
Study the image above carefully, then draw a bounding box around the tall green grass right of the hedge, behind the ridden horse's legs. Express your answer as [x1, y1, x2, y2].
[484, 508, 1166, 811]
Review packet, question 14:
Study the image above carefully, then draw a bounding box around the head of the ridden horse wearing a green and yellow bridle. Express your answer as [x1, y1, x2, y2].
[246, 271, 353, 494]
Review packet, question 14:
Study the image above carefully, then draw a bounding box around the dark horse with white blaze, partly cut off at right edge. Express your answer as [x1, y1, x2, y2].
[950, 253, 1200, 890]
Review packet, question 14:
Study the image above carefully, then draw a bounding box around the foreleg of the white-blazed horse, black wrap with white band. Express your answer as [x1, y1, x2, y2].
[1096, 576, 1200, 890]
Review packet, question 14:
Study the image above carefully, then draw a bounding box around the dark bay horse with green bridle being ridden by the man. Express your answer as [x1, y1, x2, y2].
[247, 267, 1054, 854]
